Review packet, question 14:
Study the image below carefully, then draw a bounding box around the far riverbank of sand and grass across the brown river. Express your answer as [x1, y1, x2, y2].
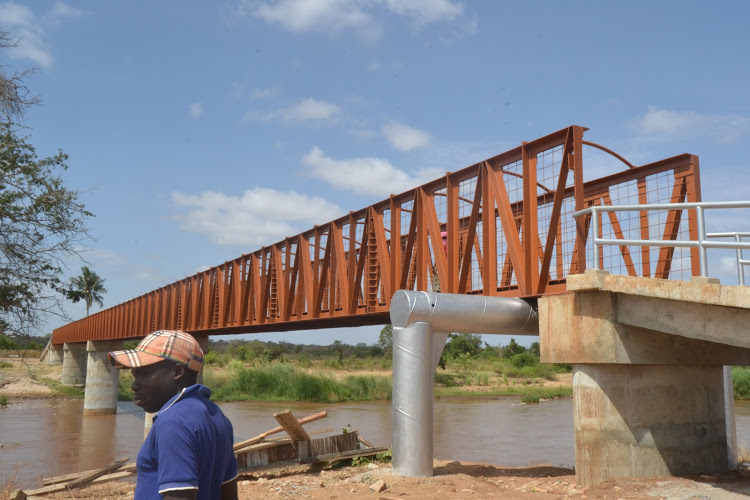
[0, 356, 572, 403]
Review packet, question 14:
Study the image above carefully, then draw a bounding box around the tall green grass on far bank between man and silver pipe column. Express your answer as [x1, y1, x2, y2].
[204, 362, 391, 403]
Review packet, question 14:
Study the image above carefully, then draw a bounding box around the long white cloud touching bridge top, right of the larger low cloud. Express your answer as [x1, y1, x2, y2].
[302, 146, 444, 197]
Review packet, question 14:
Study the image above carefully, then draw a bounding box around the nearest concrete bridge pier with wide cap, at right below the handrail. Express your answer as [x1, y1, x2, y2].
[539, 271, 750, 486]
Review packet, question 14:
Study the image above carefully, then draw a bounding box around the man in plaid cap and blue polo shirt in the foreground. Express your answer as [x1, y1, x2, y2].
[108, 330, 237, 500]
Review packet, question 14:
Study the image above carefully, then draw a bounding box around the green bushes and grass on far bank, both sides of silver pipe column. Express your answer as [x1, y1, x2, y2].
[192, 325, 571, 403]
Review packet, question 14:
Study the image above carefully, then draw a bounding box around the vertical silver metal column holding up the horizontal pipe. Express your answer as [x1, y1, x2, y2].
[392, 322, 434, 476]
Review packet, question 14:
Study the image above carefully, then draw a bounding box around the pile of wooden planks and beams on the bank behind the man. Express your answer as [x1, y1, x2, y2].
[10, 410, 388, 500]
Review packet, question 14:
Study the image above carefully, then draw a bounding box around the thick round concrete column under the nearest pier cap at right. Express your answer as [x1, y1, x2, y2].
[573, 364, 728, 486]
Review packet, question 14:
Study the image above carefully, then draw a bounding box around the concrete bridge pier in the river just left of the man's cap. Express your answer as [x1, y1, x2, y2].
[83, 340, 122, 415]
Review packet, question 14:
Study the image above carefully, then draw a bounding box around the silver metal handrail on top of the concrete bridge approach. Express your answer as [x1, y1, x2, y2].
[573, 201, 750, 284]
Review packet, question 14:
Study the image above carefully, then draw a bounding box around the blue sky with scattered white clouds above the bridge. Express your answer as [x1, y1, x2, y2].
[0, 0, 750, 345]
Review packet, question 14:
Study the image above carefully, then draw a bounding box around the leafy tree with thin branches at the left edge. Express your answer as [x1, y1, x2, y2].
[0, 30, 92, 350]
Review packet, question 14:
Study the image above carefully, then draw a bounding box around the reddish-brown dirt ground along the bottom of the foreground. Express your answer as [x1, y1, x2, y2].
[14, 461, 750, 500]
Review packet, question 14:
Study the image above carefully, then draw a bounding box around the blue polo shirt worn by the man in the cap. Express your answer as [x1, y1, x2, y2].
[133, 384, 237, 500]
